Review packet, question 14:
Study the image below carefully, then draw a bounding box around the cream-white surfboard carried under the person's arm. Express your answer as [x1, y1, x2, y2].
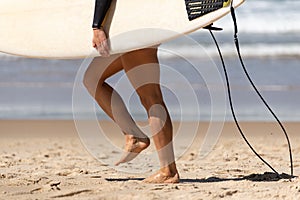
[0, 0, 244, 59]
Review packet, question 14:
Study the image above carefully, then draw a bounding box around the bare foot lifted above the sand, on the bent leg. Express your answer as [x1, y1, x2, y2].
[115, 135, 150, 166]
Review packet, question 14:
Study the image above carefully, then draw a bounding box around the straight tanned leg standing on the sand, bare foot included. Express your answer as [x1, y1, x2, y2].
[122, 48, 179, 183]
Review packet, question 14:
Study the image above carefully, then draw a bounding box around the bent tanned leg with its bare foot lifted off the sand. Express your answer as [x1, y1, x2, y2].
[84, 57, 150, 165]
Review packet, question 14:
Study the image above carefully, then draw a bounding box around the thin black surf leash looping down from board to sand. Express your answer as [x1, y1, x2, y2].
[205, 1, 294, 178]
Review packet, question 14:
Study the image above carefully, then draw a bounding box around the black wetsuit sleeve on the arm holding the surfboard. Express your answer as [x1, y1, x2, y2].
[92, 0, 112, 28]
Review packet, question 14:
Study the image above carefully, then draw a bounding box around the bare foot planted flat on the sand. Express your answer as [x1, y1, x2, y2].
[143, 170, 180, 183]
